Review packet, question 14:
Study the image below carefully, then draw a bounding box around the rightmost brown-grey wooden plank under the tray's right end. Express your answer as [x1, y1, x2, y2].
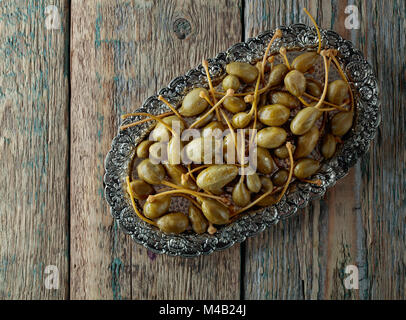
[244, 0, 406, 299]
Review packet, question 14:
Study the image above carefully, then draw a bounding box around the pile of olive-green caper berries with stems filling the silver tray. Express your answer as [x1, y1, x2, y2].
[123, 46, 354, 234]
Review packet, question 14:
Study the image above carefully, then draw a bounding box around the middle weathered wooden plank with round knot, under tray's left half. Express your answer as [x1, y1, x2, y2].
[71, 1, 241, 299]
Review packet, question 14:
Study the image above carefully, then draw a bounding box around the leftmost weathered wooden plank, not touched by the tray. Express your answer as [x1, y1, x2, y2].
[0, 0, 69, 300]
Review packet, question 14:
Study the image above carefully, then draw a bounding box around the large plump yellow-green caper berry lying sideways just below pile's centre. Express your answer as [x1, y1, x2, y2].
[196, 164, 238, 194]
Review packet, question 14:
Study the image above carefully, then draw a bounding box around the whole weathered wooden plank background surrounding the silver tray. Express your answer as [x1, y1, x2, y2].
[0, 0, 406, 299]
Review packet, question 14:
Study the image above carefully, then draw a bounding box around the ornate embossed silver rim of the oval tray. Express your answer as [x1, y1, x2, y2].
[104, 24, 381, 257]
